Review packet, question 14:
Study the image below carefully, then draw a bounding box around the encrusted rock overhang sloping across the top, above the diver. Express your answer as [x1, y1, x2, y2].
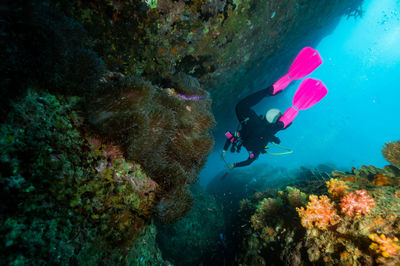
[48, 0, 362, 127]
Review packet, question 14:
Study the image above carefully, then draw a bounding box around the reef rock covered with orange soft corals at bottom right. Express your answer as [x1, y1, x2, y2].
[238, 159, 400, 265]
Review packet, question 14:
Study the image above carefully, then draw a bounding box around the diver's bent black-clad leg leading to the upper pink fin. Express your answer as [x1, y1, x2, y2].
[236, 86, 273, 122]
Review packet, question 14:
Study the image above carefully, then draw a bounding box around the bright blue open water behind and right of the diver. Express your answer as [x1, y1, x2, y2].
[200, 0, 400, 185]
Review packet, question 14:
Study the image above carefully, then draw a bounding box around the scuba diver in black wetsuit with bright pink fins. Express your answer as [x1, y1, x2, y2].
[221, 47, 328, 169]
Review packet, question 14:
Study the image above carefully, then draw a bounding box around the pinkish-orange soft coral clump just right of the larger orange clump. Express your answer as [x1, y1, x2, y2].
[340, 190, 375, 216]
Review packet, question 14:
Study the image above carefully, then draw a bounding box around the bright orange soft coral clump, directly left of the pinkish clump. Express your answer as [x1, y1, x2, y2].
[296, 195, 340, 230]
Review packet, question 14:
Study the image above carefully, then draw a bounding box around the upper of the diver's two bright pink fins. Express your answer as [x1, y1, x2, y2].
[272, 47, 322, 94]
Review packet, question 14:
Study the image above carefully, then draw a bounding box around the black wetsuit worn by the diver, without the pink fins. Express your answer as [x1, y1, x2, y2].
[224, 86, 287, 167]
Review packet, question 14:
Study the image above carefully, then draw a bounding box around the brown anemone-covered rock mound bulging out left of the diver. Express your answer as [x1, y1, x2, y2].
[87, 74, 215, 222]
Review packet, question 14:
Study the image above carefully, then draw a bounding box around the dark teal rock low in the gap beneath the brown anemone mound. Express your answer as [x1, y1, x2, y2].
[157, 184, 223, 265]
